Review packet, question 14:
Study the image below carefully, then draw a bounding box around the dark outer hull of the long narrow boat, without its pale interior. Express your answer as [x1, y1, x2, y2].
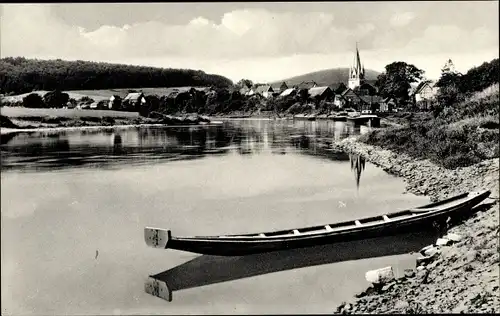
[146, 191, 490, 256]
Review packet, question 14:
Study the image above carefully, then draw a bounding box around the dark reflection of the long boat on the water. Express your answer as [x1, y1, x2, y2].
[145, 228, 438, 301]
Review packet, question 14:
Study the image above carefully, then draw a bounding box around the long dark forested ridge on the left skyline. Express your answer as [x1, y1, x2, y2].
[0, 57, 233, 94]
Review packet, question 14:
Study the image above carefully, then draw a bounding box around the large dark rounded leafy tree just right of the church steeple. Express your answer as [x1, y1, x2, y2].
[375, 61, 424, 105]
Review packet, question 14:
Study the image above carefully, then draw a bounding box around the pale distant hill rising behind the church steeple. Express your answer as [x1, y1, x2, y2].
[271, 67, 380, 86]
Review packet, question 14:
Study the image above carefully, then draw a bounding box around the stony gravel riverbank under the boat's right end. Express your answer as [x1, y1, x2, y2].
[330, 137, 500, 314]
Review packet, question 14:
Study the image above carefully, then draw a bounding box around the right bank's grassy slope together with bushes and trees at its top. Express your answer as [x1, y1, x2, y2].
[360, 59, 500, 169]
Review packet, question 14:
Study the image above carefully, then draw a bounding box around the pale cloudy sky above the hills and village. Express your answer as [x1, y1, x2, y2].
[0, 1, 499, 82]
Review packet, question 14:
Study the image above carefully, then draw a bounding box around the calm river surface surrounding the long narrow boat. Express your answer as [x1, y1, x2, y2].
[1, 120, 428, 315]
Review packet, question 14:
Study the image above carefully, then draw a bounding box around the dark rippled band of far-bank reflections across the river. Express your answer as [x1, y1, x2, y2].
[1, 121, 368, 171]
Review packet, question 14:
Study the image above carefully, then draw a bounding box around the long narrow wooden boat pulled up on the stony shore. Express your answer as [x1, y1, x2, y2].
[144, 190, 490, 256]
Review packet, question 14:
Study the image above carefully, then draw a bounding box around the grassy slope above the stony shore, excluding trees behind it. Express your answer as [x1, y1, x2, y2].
[360, 85, 500, 169]
